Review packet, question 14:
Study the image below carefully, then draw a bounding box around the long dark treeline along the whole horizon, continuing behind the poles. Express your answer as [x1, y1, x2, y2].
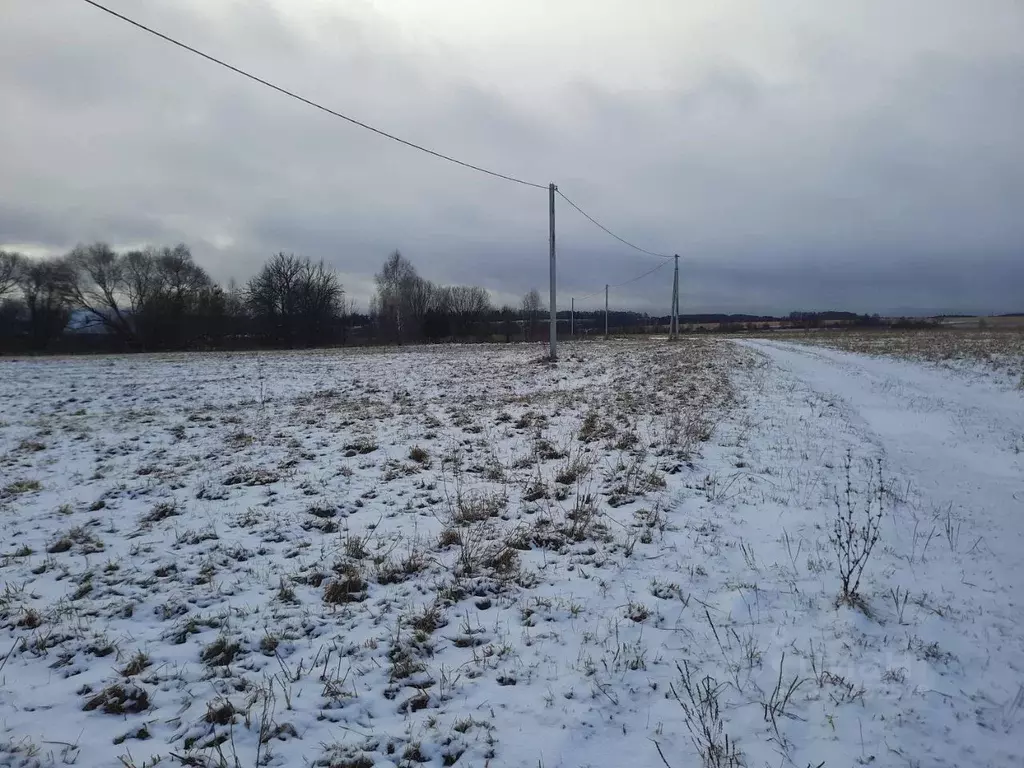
[0, 243, 942, 353]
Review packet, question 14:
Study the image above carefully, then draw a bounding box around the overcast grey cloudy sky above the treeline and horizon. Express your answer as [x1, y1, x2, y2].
[0, 0, 1024, 313]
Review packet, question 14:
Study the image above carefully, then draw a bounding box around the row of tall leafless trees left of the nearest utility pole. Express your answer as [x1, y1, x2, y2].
[0, 237, 512, 350]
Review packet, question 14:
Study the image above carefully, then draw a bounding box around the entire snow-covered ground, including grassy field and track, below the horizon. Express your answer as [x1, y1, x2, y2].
[0, 339, 1024, 768]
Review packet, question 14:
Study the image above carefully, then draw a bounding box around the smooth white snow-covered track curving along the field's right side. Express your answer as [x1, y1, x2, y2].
[745, 341, 1024, 573]
